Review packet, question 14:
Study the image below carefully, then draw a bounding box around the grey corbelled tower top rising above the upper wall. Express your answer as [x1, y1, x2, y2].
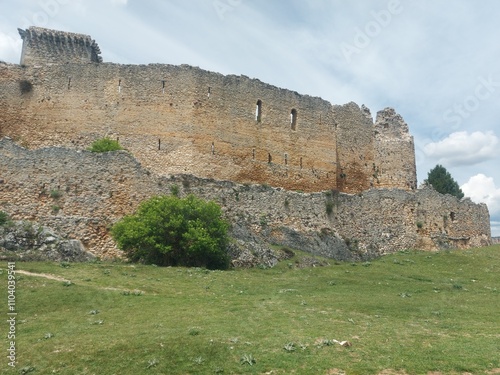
[18, 26, 102, 65]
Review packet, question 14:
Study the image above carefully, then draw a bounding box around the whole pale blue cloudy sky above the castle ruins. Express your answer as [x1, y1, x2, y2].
[0, 0, 500, 236]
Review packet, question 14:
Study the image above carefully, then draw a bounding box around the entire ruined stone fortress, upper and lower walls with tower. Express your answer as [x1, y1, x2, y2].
[0, 28, 491, 259]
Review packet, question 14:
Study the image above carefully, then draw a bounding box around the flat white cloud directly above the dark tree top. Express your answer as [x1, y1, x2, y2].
[424, 131, 498, 166]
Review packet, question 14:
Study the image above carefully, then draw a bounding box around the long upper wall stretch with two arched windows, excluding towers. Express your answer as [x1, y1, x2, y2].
[0, 60, 337, 191]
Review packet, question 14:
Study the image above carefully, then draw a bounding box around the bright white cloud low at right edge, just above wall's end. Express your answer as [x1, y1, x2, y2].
[460, 173, 500, 218]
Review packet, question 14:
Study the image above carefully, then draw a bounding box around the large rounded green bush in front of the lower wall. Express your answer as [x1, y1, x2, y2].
[111, 195, 230, 269]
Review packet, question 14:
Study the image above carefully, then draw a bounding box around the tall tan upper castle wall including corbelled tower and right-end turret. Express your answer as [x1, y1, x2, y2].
[0, 27, 417, 193]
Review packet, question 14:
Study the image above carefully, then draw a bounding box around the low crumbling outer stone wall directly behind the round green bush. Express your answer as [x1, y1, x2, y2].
[0, 139, 491, 260]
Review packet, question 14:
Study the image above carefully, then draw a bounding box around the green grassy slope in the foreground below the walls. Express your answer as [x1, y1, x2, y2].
[0, 246, 500, 375]
